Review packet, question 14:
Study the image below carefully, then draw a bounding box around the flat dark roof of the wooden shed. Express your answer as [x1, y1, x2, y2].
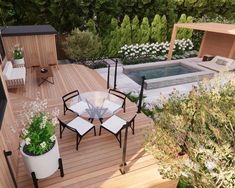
[0, 25, 57, 36]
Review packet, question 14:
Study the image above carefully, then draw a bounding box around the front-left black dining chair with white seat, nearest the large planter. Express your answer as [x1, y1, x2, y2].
[58, 117, 96, 150]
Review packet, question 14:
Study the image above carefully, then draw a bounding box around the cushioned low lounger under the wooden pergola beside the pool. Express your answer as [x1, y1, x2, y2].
[198, 56, 235, 72]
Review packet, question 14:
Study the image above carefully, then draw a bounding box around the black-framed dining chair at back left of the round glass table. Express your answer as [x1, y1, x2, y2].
[62, 90, 88, 116]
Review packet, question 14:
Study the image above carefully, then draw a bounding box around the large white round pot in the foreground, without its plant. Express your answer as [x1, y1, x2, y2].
[20, 139, 60, 179]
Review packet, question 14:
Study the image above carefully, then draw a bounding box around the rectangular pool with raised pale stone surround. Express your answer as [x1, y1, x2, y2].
[123, 60, 214, 89]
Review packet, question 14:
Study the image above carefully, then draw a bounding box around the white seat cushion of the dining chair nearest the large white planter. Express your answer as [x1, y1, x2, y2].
[67, 117, 94, 136]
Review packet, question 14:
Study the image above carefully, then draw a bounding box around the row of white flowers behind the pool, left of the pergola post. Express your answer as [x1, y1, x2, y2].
[119, 42, 170, 59]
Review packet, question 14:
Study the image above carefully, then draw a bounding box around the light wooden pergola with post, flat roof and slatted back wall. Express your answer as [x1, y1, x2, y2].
[167, 23, 235, 60]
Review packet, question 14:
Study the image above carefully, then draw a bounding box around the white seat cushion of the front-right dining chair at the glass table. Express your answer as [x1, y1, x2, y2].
[101, 115, 127, 134]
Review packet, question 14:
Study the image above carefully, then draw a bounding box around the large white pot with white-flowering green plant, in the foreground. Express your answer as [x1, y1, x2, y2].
[20, 98, 60, 179]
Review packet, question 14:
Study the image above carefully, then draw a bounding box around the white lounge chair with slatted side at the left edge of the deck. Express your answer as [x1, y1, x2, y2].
[3, 61, 26, 89]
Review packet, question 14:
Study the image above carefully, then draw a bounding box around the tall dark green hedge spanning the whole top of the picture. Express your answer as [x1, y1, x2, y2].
[0, 0, 235, 32]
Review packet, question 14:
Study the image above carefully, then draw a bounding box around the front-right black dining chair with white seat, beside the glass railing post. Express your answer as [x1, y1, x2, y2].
[99, 114, 137, 148]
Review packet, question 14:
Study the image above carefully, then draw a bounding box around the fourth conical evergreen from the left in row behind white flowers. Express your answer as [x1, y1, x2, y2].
[138, 17, 150, 44]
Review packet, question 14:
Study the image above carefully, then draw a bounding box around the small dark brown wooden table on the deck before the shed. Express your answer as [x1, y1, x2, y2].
[36, 67, 54, 86]
